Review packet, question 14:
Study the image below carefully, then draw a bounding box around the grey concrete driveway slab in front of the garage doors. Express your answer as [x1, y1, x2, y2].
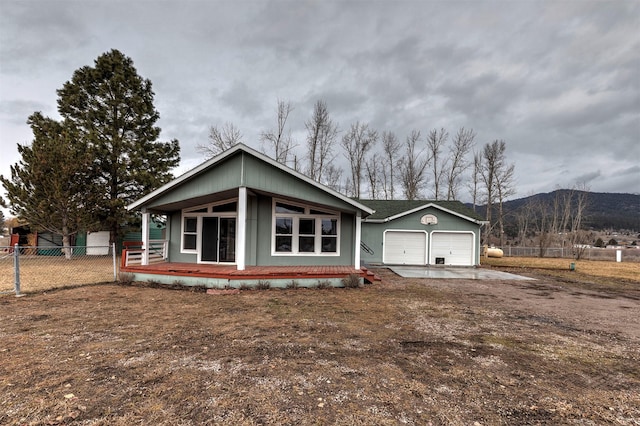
[389, 266, 535, 280]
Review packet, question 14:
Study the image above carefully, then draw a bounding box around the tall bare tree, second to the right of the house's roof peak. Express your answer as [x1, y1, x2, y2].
[305, 100, 338, 183]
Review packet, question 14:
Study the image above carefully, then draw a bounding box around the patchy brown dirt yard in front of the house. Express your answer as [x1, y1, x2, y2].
[0, 262, 640, 425]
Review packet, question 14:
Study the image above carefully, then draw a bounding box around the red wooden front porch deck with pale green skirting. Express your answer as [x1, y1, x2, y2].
[120, 262, 379, 288]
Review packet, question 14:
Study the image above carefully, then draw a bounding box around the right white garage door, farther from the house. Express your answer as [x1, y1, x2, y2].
[429, 232, 474, 266]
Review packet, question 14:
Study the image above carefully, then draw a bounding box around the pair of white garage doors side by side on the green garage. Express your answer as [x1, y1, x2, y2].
[382, 229, 475, 266]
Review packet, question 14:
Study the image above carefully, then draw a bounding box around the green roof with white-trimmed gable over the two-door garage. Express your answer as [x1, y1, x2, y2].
[359, 200, 484, 225]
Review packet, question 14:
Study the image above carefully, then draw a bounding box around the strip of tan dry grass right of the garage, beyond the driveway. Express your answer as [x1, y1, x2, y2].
[481, 257, 640, 283]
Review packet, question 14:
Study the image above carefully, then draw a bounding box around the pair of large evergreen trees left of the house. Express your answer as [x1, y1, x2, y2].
[0, 50, 180, 256]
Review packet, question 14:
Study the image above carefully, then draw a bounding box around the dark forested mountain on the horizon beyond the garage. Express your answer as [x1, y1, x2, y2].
[468, 189, 640, 232]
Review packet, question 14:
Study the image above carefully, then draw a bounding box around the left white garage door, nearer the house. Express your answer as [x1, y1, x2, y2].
[383, 231, 427, 265]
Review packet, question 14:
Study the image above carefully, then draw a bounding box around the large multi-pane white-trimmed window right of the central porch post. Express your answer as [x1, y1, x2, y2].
[272, 200, 340, 255]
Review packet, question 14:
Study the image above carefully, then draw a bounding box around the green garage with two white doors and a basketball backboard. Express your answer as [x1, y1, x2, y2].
[360, 200, 485, 266]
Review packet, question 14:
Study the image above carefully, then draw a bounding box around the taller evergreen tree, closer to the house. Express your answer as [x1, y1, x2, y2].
[58, 50, 180, 243]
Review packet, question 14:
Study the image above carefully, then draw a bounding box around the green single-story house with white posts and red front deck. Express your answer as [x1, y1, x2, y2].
[121, 144, 373, 287]
